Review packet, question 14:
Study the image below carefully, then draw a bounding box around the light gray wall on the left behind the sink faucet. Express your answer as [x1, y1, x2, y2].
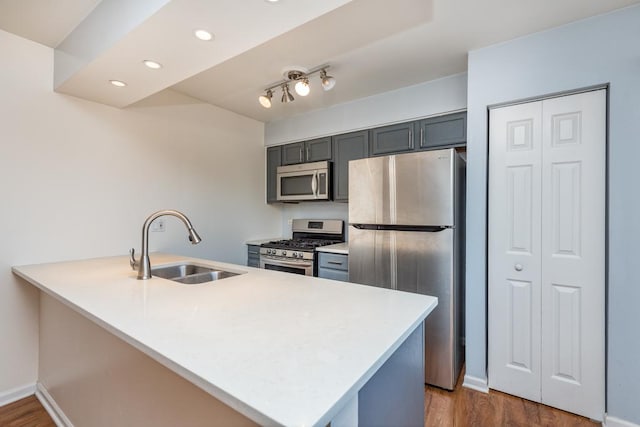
[0, 31, 281, 406]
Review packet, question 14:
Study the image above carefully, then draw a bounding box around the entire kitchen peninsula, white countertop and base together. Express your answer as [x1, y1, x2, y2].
[13, 254, 437, 427]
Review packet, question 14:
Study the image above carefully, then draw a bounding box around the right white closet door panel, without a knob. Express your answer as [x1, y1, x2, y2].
[542, 90, 606, 420]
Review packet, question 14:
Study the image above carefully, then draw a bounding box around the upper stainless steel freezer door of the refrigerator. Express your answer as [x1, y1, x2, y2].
[349, 149, 457, 226]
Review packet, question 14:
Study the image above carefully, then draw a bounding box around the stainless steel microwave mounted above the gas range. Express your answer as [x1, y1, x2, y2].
[276, 161, 331, 202]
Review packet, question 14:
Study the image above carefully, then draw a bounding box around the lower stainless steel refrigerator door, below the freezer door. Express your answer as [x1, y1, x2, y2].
[349, 227, 462, 389]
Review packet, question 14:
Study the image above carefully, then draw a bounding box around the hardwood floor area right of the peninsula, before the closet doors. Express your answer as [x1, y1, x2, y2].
[424, 371, 599, 427]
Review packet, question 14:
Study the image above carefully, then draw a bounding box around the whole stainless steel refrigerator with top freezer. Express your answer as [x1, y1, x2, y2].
[349, 149, 465, 390]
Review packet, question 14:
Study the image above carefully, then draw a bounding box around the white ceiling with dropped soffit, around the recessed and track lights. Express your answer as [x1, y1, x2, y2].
[0, 0, 640, 122]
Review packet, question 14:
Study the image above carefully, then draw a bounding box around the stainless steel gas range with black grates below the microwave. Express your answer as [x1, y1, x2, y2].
[260, 219, 344, 276]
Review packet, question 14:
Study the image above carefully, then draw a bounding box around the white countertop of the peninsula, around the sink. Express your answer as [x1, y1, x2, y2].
[13, 254, 437, 427]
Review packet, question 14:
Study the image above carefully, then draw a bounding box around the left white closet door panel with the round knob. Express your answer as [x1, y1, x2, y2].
[488, 102, 542, 401]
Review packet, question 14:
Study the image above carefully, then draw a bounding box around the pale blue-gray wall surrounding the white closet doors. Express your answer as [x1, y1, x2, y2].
[466, 6, 640, 424]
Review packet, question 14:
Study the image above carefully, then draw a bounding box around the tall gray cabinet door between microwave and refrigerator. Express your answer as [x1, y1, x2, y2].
[332, 130, 369, 202]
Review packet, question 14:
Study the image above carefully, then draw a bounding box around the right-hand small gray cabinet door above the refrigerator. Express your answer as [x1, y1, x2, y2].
[418, 113, 467, 150]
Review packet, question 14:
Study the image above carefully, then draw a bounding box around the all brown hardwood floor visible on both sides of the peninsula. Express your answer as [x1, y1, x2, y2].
[0, 374, 598, 427]
